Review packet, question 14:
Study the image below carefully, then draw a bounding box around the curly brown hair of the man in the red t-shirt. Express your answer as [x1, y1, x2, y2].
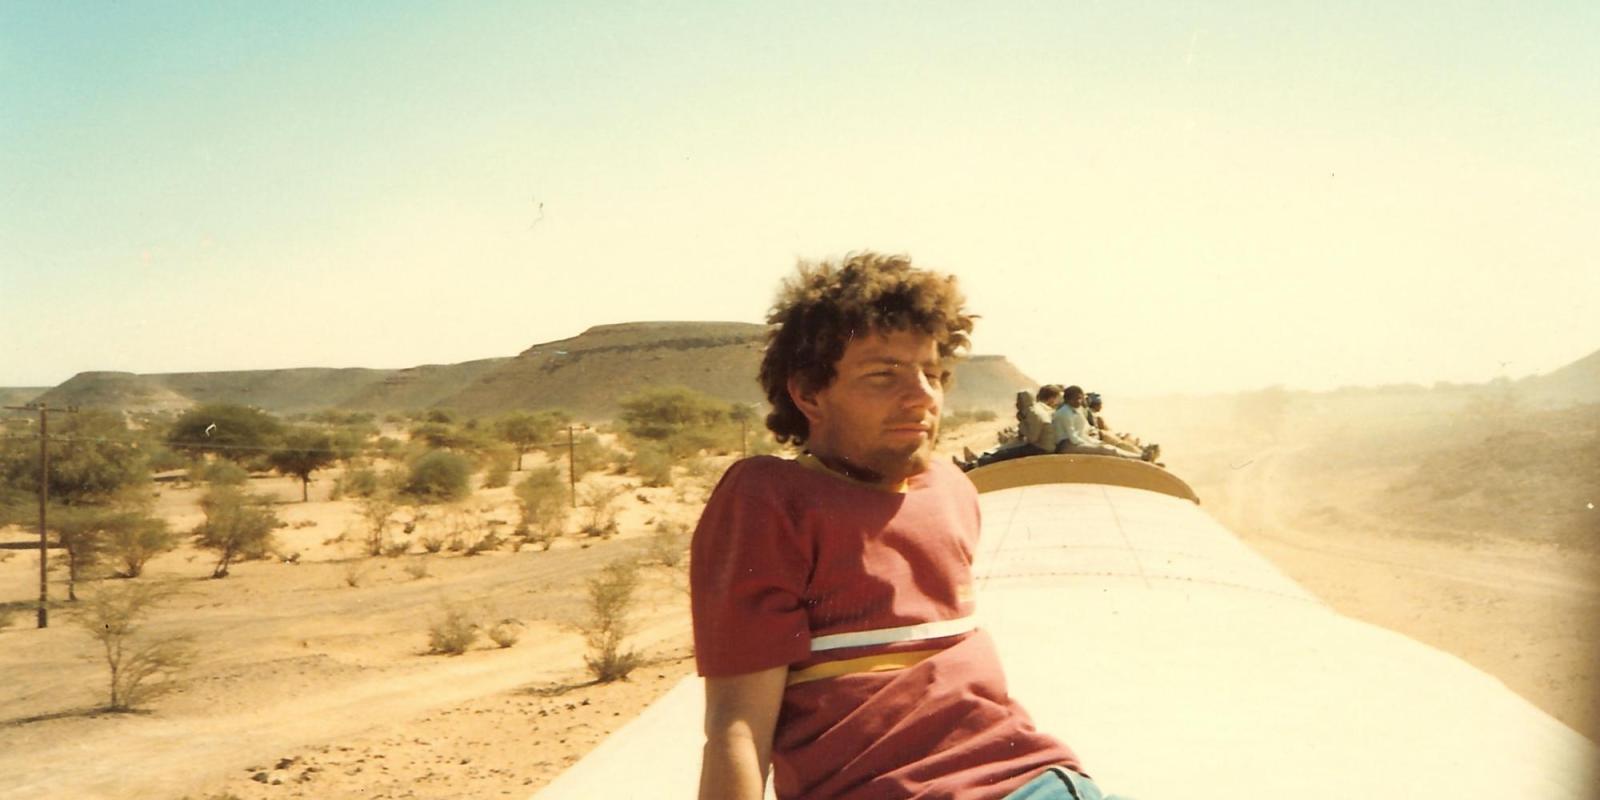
[760, 251, 978, 445]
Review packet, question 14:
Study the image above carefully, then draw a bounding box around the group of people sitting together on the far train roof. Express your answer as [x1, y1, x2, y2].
[957, 384, 1162, 469]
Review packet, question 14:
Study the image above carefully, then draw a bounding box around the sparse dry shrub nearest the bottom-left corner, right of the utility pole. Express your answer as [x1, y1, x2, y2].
[74, 582, 194, 710]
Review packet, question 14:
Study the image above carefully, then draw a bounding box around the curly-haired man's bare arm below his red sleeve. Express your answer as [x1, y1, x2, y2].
[699, 667, 789, 800]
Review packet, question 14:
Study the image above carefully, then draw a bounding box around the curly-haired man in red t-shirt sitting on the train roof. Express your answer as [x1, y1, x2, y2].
[690, 253, 1120, 800]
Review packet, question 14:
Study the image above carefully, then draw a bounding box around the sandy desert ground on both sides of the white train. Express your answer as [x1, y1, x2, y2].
[0, 406, 1600, 800]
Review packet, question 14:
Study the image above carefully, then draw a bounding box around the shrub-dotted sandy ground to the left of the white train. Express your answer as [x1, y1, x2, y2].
[0, 459, 715, 798]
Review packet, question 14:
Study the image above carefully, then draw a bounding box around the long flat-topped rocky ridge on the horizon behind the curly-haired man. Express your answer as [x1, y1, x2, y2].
[18, 322, 1037, 421]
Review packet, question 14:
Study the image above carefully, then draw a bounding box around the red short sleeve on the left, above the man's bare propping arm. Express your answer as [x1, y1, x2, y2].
[690, 464, 811, 677]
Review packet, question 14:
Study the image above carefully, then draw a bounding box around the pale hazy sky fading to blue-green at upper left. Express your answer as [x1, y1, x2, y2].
[0, 0, 1600, 395]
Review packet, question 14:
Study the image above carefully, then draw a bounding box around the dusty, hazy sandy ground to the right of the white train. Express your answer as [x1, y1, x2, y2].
[1163, 396, 1600, 741]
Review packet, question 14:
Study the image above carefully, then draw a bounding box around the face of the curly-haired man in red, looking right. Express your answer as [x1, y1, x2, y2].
[789, 331, 949, 485]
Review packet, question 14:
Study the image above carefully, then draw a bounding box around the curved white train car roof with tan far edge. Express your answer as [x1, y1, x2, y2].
[536, 456, 1600, 800]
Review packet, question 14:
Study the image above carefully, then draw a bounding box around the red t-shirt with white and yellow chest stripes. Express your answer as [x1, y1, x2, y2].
[690, 456, 1080, 800]
